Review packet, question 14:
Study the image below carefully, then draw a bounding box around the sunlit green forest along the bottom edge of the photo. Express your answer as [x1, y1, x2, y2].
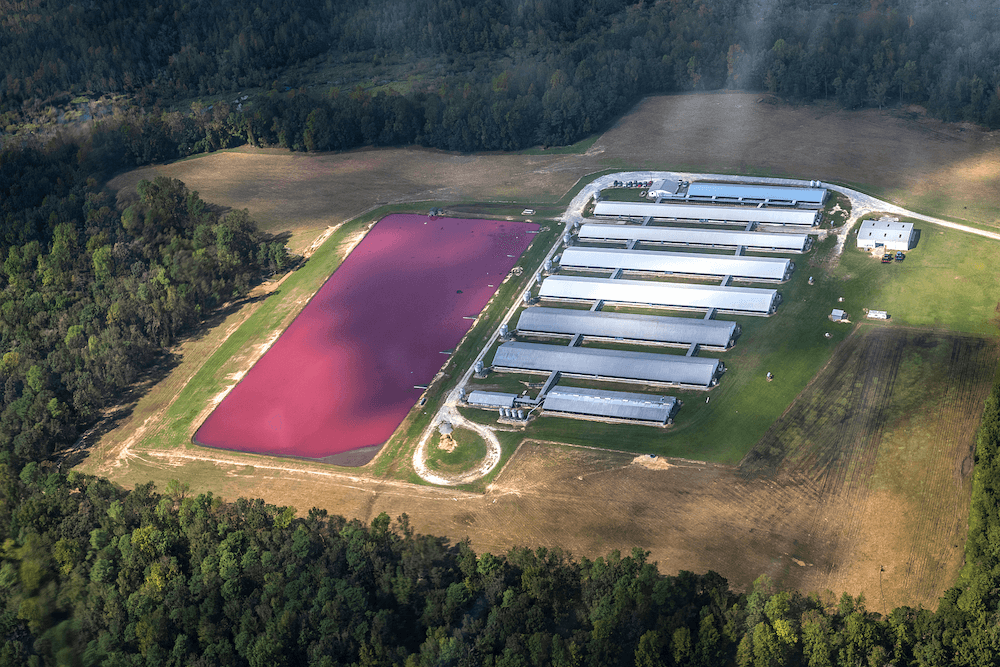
[0, 374, 1000, 667]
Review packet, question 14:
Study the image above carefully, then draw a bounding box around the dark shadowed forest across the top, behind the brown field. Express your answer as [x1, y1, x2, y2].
[0, 0, 1000, 161]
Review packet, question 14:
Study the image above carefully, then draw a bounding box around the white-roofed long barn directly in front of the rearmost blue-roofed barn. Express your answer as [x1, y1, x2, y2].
[594, 200, 820, 227]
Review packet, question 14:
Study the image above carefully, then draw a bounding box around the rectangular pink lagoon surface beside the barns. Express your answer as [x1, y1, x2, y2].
[194, 214, 538, 458]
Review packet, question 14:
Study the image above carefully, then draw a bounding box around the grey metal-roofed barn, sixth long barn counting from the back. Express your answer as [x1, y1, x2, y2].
[517, 306, 740, 350]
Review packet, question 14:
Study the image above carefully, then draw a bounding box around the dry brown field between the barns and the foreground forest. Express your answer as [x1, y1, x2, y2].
[92, 326, 1000, 612]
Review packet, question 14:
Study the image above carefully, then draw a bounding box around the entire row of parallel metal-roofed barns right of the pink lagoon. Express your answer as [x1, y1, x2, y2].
[468, 184, 826, 425]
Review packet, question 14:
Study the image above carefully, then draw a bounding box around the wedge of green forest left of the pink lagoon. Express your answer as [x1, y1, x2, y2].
[0, 145, 289, 469]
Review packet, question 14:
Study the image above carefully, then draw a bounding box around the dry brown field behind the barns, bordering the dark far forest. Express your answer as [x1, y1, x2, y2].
[112, 93, 1000, 252]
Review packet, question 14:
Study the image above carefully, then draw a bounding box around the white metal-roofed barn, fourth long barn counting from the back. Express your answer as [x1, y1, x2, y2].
[559, 247, 795, 282]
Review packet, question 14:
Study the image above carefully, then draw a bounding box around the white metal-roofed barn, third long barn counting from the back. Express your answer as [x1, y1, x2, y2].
[579, 223, 812, 252]
